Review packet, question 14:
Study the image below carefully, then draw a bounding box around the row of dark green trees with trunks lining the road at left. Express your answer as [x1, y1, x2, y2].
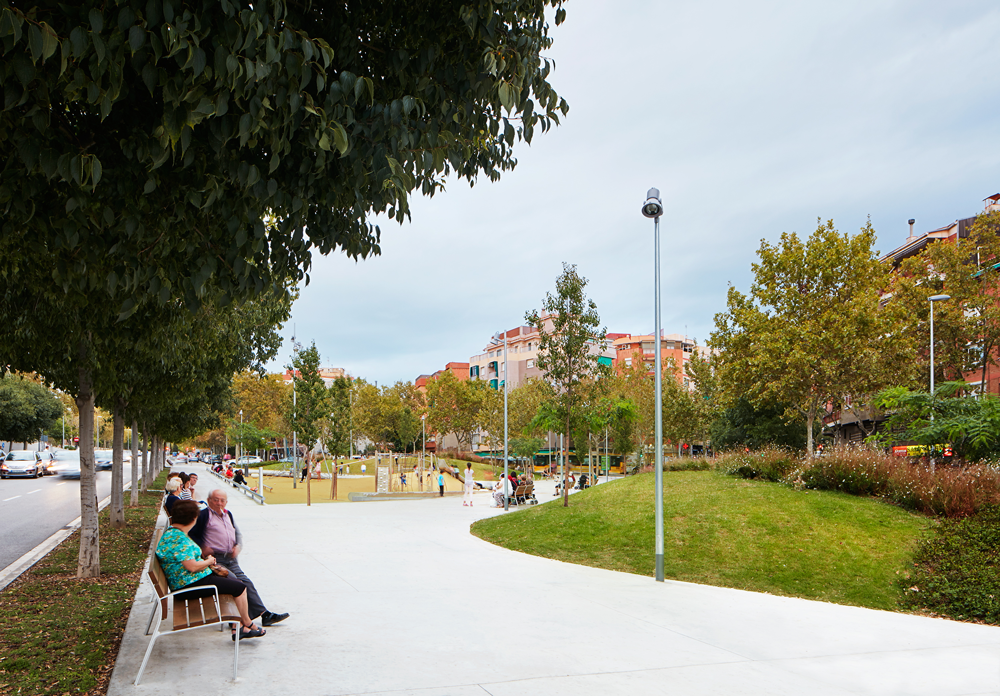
[0, 0, 568, 577]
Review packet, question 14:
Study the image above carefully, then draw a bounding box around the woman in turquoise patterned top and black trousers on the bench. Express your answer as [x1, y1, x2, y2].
[156, 500, 265, 640]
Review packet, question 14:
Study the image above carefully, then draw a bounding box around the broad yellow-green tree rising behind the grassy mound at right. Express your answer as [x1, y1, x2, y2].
[711, 220, 912, 456]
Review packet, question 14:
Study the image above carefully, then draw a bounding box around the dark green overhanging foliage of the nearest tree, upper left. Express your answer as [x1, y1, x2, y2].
[0, 0, 568, 315]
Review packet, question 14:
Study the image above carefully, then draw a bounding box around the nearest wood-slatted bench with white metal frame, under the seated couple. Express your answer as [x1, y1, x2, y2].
[135, 536, 241, 686]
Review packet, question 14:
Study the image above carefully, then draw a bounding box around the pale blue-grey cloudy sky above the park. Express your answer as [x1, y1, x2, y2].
[270, 0, 1000, 385]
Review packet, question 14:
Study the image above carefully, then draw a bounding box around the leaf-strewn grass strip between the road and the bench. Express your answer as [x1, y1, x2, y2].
[0, 474, 166, 694]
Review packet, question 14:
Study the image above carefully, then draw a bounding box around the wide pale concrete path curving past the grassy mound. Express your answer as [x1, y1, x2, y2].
[108, 480, 1000, 696]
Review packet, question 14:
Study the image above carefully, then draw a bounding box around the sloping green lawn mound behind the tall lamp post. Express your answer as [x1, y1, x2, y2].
[472, 471, 936, 610]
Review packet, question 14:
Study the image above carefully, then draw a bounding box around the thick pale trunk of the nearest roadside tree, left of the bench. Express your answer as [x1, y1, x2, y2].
[76, 362, 101, 578]
